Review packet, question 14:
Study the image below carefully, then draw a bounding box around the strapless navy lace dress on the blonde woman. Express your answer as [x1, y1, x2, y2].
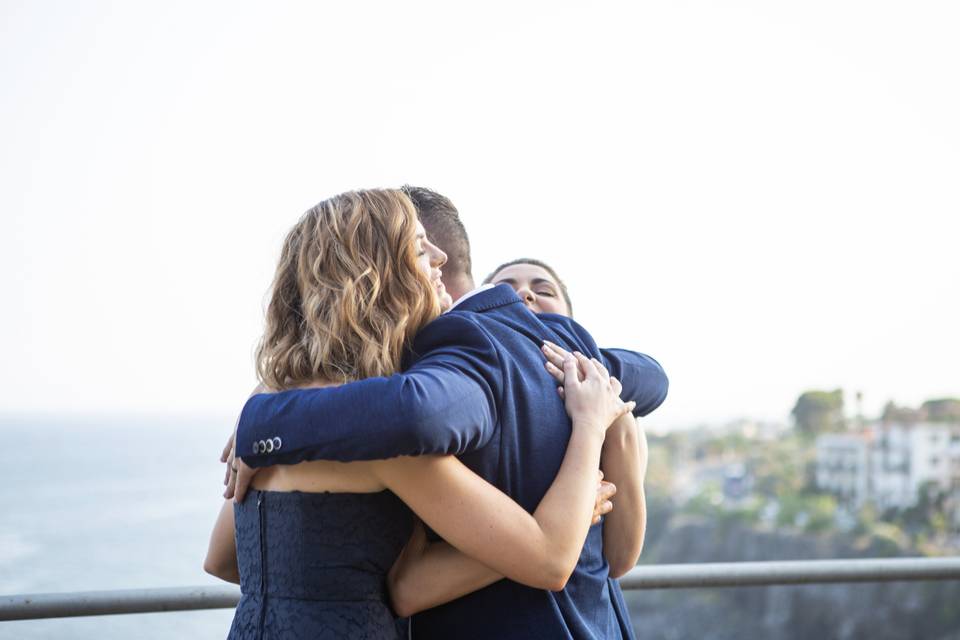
[228, 491, 413, 640]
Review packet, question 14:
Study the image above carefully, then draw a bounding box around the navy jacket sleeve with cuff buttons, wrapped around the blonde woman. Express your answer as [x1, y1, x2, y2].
[237, 313, 503, 467]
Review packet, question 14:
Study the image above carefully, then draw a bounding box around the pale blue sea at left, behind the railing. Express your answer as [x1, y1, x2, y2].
[0, 415, 240, 640]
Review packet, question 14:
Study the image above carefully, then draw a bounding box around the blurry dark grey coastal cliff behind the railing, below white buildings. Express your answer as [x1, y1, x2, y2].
[625, 510, 960, 640]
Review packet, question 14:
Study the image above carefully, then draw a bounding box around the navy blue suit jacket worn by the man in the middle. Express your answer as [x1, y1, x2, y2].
[237, 285, 667, 639]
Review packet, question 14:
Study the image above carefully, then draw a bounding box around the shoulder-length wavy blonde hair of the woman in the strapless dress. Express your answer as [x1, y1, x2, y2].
[256, 189, 440, 390]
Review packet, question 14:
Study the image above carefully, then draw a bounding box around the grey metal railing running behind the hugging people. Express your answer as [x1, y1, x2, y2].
[0, 557, 960, 621]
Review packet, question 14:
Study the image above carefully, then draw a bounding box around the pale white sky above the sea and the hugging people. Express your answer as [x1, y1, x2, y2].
[0, 0, 960, 427]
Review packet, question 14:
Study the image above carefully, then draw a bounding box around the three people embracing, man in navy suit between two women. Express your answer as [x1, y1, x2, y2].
[205, 187, 667, 639]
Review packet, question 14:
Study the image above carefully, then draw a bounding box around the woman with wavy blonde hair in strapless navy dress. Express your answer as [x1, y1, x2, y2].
[205, 190, 632, 639]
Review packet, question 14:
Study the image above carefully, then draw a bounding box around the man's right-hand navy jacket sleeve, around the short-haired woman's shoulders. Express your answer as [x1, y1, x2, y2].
[549, 315, 669, 416]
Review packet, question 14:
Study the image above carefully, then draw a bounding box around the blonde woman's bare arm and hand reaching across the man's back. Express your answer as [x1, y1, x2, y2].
[377, 356, 630, 609]
